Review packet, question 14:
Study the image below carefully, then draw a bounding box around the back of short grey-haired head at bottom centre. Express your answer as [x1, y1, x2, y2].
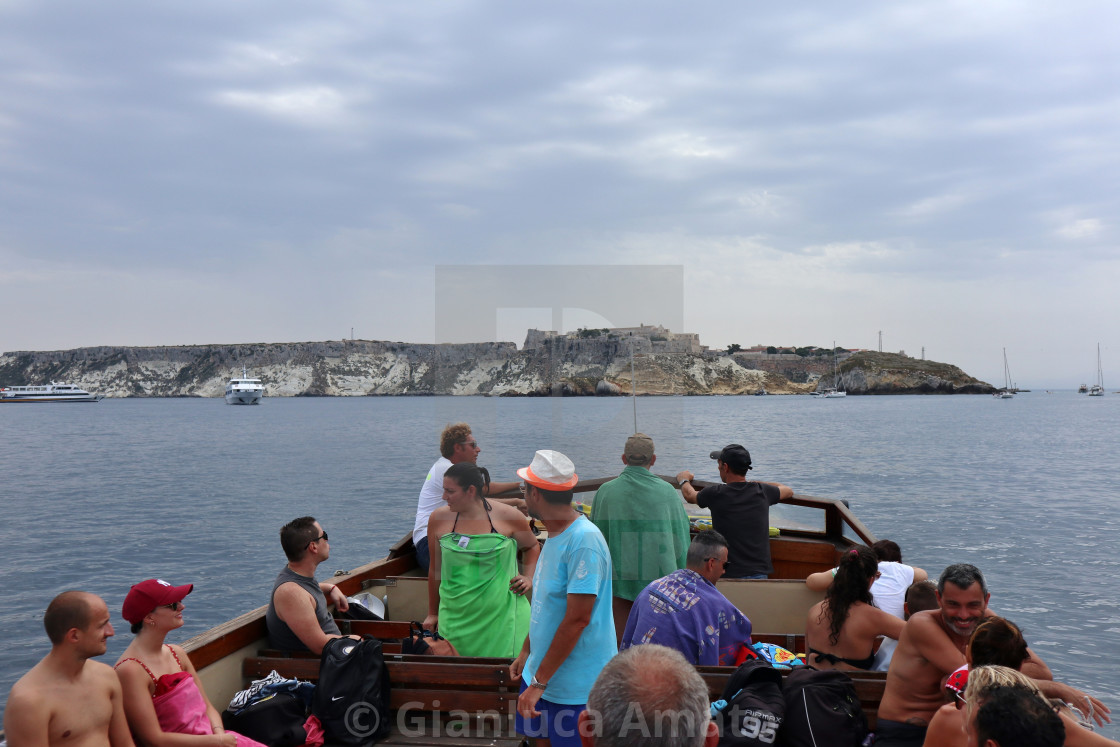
[579, 644, 719, 747]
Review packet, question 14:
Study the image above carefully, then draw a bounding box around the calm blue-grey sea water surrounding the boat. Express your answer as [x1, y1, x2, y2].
[0, 392, 1120, 738]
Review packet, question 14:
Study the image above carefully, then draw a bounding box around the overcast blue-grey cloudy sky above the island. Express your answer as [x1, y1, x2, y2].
[0, 0, 1120, 387]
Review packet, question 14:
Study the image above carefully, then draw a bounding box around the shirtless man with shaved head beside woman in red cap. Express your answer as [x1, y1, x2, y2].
[3, 591, 133, 747]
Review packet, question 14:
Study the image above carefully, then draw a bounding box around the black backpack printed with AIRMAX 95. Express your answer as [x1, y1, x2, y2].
[711, 659, 785, 747]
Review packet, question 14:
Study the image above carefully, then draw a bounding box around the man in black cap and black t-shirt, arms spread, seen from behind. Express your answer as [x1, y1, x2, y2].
[676, 443, 793, 579]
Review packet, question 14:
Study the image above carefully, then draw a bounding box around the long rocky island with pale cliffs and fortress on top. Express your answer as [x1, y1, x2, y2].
[0, 325, 995, 398]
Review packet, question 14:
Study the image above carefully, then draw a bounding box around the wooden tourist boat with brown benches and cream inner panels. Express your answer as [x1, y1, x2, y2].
[184, 476, 886, 746]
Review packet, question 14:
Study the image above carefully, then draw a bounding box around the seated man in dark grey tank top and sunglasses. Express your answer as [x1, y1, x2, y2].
[264, 516, 348, 654]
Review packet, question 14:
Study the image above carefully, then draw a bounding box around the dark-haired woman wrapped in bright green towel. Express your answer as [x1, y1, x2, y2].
[423, 461, 541, 657]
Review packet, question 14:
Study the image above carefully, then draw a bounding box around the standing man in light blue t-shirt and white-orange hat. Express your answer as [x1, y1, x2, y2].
[510, 450, 617, 746]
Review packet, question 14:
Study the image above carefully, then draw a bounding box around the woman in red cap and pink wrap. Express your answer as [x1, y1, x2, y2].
[114, 578, 263, 747]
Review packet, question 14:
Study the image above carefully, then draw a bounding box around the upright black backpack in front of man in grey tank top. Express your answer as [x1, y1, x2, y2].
[311, 636, 391, 747]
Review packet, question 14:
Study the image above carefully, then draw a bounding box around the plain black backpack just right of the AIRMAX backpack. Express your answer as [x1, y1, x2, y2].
[780, 666, 868, 747]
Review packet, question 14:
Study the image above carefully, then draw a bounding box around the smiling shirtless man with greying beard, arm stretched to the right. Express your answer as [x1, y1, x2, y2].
[875, 563, 1109, 747]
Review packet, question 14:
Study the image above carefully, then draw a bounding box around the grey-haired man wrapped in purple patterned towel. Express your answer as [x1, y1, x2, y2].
[618, 530, 750, 666]
